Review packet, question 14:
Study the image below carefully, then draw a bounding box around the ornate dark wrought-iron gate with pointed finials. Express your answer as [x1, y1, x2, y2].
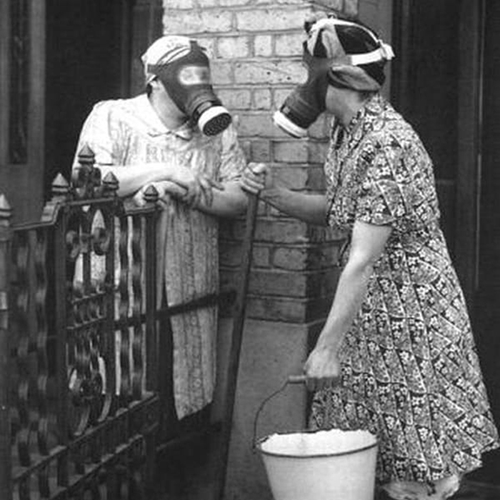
[0, 149, 159, 500]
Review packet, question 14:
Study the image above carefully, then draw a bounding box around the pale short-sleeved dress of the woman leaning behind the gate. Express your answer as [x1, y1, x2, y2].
[75, 94, 246, 419]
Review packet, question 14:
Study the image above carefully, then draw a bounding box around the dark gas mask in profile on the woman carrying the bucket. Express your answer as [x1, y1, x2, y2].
[273, 43, 331, 138]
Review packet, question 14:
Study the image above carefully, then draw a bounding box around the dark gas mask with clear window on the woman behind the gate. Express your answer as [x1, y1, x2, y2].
[149, 41, 231, 136]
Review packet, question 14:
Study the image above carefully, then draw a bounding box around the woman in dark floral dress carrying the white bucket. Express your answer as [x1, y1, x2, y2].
[240, 13, 498, 500]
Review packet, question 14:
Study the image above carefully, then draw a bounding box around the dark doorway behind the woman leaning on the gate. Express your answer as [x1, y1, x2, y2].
[45, 0, 132, 198]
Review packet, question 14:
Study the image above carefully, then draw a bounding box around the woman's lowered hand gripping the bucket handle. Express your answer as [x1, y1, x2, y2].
[304, 345, 341, 391]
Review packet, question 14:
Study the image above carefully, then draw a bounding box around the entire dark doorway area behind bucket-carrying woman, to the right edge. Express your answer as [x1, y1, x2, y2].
[392, 0, 500, 484]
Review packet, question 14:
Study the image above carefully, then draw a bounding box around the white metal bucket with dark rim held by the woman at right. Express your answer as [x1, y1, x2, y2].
[254, 378, 377, 500]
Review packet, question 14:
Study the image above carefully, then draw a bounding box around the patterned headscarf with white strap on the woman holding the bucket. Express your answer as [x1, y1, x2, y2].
[305, 18, 394, 91]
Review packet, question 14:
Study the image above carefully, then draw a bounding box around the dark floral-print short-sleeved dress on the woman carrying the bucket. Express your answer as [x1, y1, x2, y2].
[311, 95, 498, 483]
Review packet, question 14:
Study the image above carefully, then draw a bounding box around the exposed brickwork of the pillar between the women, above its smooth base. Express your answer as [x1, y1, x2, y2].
[163, 0, 357, 323]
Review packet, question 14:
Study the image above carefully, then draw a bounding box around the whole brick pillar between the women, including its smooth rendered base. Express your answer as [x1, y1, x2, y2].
[156, 0, 392, 500]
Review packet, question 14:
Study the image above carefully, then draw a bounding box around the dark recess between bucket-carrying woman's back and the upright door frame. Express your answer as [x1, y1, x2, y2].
[391, 0, 459, 254]
